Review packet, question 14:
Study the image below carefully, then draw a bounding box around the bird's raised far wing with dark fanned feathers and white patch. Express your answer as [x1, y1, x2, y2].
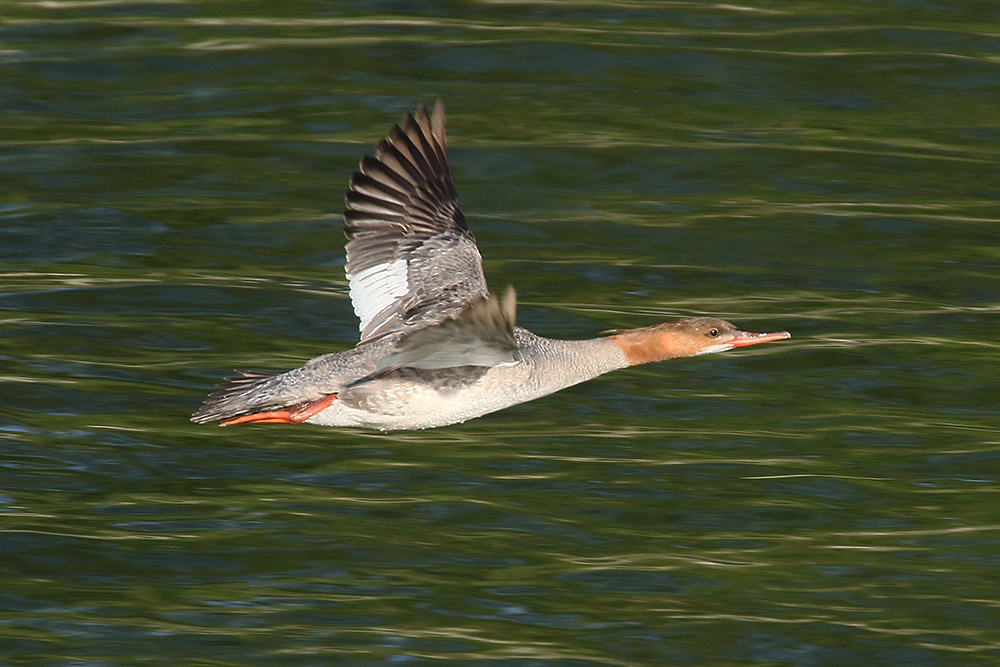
[344, 100, 489, 350]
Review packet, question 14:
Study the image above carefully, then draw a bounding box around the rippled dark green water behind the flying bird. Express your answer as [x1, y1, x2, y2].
[0, 0, 1000, 666]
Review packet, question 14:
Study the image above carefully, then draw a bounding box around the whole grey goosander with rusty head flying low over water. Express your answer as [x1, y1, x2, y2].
[191, 100, 790, 431]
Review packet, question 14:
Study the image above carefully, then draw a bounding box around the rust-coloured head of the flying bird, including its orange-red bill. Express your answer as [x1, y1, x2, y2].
[611, 317, 792, 366]
